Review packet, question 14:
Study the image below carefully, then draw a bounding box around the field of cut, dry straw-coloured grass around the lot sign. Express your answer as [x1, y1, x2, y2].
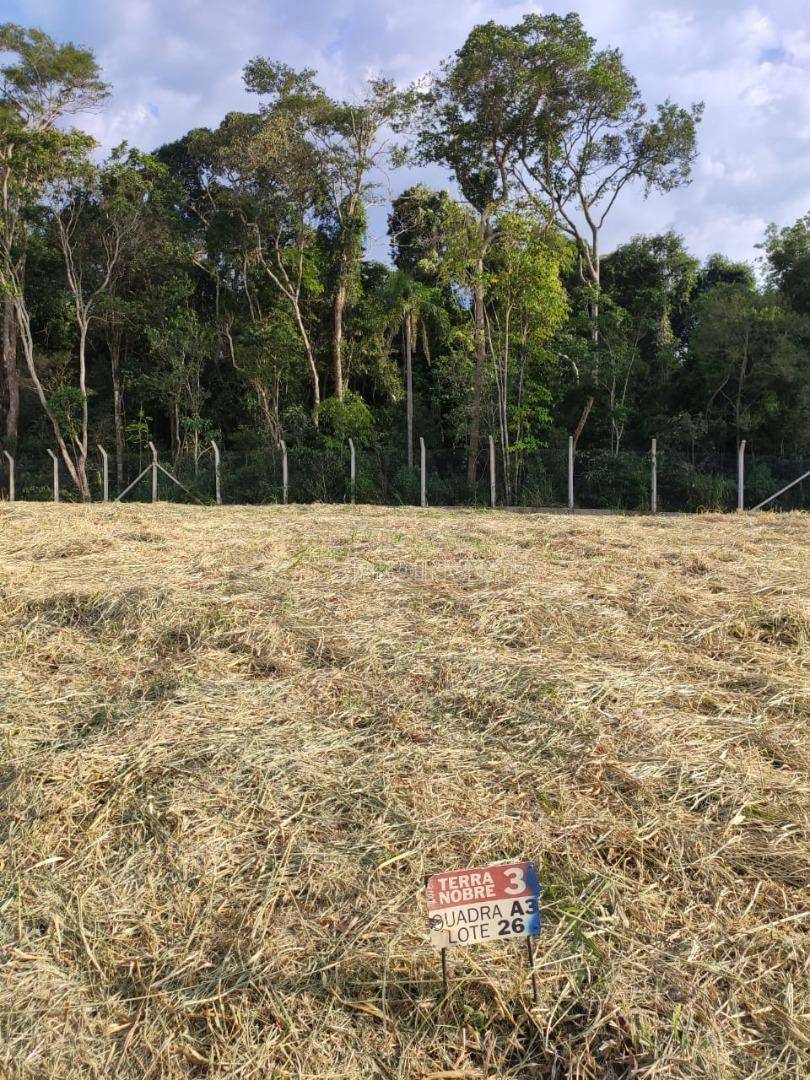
[0, 504, 810, 1080]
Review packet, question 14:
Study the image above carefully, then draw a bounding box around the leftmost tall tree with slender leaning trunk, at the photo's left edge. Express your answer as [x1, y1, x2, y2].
[0, 23, 108, 455]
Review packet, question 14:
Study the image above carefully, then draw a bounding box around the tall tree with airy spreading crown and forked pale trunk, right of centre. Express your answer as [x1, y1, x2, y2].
[516, 14, 703, 354]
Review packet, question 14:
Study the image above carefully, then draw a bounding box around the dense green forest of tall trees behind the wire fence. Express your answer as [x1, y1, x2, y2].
[0, 14, 810, 510]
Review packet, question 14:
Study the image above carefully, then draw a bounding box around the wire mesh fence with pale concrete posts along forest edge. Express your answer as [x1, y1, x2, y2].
[0, 443, 810, 512]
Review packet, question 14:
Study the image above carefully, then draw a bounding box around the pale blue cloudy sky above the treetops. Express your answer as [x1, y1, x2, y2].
[0, 0, 810, 261]
